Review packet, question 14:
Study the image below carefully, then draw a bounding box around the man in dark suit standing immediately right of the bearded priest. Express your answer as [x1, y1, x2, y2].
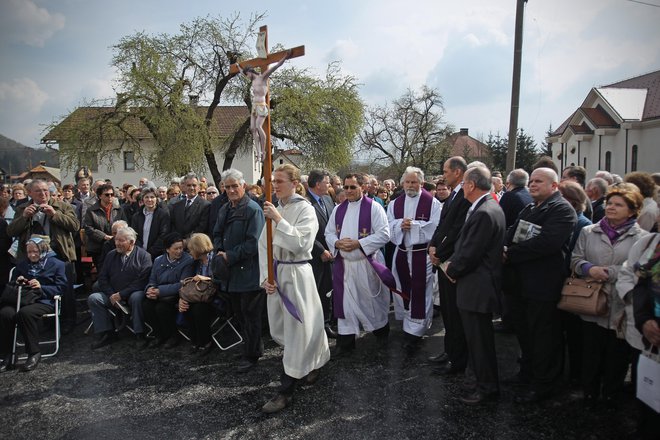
[429, 156, 471, 375]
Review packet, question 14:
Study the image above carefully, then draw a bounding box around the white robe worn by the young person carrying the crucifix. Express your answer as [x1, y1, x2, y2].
[259, 195, 330, 379]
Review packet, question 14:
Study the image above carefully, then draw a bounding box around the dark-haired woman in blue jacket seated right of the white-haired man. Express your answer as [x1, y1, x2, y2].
[142, 232, 194, 348]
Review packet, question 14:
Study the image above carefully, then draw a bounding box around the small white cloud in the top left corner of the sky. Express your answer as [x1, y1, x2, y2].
[0, 0, 65, 47]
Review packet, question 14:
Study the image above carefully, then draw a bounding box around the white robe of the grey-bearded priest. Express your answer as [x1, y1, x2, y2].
[387, 193, 442, 336]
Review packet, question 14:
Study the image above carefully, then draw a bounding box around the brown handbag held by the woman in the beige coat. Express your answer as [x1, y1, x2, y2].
[557, 273, 608, 316]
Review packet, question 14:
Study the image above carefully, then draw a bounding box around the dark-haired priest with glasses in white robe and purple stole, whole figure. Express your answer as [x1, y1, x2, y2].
[325, 174, 390, 356]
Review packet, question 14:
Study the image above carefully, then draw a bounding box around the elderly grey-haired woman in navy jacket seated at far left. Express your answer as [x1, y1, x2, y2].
[0, 235, 67, 372]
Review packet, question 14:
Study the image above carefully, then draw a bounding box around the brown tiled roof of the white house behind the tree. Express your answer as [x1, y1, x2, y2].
[41, 106, 249, 142]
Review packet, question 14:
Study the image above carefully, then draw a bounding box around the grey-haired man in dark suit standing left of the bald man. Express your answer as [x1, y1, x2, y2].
[445, 167, 506, 405]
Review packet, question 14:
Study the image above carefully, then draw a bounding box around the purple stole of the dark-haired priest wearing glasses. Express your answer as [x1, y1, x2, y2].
[332, 195, 398, 319]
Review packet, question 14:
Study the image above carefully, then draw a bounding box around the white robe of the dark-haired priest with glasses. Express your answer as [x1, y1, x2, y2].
[325, 199, 390, 335]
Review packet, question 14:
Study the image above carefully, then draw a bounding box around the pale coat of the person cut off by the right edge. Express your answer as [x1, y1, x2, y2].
[616, 234, 660, 350]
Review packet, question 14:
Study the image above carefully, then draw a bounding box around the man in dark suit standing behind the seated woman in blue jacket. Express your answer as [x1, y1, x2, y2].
[170, 174, 210, 238]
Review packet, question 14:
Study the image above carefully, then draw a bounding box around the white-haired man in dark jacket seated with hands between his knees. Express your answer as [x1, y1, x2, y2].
[87, 227, 151, 350]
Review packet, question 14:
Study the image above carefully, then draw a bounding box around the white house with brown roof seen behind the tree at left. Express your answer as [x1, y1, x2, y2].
[42, 106, 262, 185]
